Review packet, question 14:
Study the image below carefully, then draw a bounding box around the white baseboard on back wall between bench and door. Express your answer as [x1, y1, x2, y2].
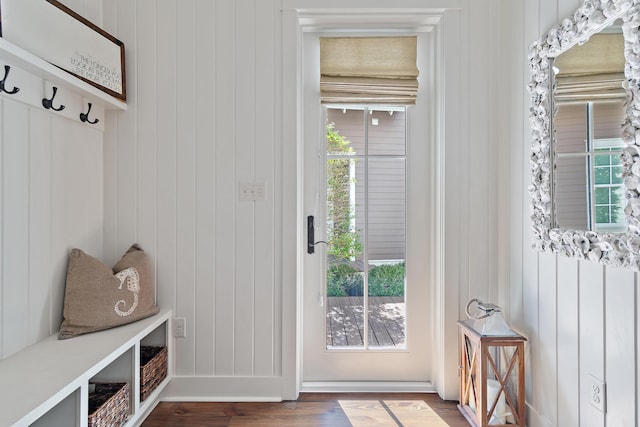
[160, 376, 282, 402]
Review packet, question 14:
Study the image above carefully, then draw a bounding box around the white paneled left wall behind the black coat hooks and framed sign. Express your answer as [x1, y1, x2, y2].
[0, 1, 104, 359]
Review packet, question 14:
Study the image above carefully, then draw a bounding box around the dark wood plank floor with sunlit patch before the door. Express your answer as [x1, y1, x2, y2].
[142, 393, 469, 427]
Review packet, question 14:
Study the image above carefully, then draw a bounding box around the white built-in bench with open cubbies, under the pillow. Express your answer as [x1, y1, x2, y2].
[0, 310, 173, 427]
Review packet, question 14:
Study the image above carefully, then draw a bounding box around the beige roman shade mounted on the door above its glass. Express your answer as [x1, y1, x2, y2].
[320, 37, 418, 105]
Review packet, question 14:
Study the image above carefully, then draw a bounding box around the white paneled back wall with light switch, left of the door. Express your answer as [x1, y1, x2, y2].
[104, 0, 280, 397]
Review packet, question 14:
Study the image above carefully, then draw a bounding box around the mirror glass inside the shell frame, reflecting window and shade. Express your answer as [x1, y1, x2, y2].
[552, 22, 626, 232]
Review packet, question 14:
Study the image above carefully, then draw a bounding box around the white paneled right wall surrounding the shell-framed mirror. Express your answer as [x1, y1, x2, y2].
[502, 0, 640, 427]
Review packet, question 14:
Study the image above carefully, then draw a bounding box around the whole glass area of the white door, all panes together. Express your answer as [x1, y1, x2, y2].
[326, 107, 406, 349]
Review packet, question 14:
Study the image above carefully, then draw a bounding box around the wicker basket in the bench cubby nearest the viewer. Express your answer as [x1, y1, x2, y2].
[88, 383, 129, 427]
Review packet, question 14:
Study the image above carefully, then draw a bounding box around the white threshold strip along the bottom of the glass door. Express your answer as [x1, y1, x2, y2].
[300, 381, 436, 393]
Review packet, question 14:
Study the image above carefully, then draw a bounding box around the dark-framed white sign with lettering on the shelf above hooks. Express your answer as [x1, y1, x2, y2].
[0, 0, 126, 101]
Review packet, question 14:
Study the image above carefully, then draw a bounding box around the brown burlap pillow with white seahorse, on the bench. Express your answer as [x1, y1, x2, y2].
[58, 245, 159, 339]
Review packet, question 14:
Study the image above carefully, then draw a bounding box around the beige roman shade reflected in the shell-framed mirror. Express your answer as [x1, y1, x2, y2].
[554, 33, 626, 104]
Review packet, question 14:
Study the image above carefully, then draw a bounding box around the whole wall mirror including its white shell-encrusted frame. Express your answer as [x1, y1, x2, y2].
[529, 0, 640, 270]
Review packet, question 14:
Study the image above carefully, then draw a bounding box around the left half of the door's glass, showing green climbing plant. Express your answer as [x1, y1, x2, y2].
[326, 108, 365, 348]
